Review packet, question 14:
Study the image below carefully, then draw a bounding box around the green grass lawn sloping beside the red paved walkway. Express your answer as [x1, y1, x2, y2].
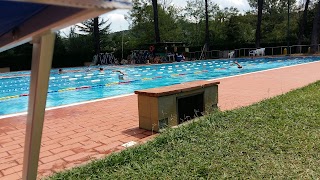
[50, 82, 320, 179]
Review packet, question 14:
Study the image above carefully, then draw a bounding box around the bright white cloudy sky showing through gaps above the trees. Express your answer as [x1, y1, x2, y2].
[63, 0, 250, 32]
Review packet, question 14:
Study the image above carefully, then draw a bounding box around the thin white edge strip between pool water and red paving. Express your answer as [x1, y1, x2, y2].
[0, 57, 320, 120]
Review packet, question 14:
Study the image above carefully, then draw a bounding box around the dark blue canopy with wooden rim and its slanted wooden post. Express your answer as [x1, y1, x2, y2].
[0, 0, 132, 180]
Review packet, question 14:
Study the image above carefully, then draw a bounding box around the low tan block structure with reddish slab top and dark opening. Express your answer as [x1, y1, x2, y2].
[135, 81, 219, 132]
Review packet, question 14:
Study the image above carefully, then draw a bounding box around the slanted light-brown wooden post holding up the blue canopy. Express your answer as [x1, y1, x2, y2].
[22, 33, 55, 180]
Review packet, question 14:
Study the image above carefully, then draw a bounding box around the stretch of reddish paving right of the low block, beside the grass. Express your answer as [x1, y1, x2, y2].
[219, 62, 320, 110]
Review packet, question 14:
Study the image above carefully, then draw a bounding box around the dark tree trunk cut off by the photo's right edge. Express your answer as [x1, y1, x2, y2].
[311, 1, 320, 53]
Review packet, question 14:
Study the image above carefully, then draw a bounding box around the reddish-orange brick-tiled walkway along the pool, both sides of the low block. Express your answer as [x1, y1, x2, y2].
[0, 62, 320, 180]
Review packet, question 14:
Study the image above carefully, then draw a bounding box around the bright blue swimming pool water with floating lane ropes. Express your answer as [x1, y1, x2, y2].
[0, 57, 320, 115]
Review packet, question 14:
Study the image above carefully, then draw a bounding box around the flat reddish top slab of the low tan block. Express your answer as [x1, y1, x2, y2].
[134, 81, 220, 97]
